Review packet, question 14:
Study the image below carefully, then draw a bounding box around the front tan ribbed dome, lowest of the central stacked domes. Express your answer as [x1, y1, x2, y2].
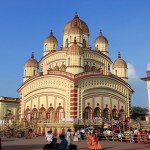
[67, 41, 83, 55]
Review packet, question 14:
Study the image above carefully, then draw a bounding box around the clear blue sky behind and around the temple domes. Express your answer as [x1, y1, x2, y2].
[0, 0, 150, 107]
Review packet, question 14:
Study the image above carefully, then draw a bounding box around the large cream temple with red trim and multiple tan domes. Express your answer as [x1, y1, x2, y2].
[18, 13, 133, 133]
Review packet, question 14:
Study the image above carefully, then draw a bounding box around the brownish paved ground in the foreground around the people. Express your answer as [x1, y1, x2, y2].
[2, 137, 150, 150]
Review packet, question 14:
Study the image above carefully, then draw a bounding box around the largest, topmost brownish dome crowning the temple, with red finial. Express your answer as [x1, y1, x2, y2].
[63, 12, 89, 35]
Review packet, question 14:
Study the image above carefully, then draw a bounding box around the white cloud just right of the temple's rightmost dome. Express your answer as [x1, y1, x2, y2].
[127, 63, 139, 78]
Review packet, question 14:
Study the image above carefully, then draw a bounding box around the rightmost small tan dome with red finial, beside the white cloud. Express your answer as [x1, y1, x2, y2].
[113, 52, 127, 68]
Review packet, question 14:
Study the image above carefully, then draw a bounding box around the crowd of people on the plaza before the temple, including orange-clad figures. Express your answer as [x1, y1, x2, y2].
[43, 128, 150, 150]
